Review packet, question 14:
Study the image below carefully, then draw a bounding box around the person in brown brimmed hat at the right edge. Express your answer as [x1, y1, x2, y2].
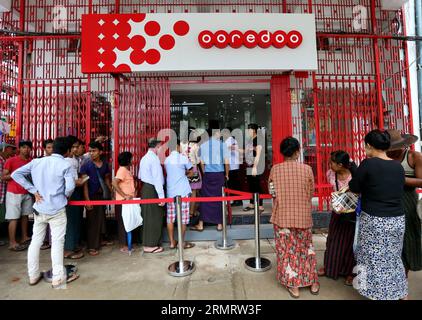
[387, 129, 422, 275]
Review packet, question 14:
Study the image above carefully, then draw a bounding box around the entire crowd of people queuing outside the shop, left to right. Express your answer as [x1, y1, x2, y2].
[0, 125, 422, 300]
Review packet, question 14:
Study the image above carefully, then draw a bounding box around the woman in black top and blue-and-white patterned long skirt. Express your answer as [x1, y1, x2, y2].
[349, 130, 408, 300]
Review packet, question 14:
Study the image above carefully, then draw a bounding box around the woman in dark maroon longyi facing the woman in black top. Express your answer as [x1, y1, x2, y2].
[318, 150, 356, 286]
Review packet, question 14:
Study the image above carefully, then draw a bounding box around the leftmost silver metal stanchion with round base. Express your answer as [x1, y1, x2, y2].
[168, 196, 195, 277]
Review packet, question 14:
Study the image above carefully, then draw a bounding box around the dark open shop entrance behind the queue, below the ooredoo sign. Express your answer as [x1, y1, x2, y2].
[170, 89, 273, 190]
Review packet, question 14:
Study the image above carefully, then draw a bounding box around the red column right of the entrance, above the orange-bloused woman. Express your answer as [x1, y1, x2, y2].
[271, 74, 293, 165]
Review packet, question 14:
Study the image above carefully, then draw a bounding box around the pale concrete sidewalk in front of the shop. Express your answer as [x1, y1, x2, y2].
[0, 235, 422, 300]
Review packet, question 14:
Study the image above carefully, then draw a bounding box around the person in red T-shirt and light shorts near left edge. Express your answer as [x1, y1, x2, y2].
[3, 141, 33, 251]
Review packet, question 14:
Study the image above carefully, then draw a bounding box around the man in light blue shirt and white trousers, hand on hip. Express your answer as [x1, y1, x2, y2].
[12, 137, 79, 288]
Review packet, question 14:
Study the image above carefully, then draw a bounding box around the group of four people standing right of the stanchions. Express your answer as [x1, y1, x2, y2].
[269, 130, 422, 300]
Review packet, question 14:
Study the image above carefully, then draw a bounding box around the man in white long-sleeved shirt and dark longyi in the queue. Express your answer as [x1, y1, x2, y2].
[138, 138, 165, 253]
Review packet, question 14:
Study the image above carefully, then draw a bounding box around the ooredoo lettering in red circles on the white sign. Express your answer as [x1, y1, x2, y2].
[198, 30, 303, 49]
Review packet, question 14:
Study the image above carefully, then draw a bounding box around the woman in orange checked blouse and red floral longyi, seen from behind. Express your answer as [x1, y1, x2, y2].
[269, 137, 319, 298]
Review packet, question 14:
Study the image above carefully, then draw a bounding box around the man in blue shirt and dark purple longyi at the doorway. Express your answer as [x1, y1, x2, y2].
[191, 127, 230, 231]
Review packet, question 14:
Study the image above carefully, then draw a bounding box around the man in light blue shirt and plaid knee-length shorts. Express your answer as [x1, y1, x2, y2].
[164, 140, 194, 249]
